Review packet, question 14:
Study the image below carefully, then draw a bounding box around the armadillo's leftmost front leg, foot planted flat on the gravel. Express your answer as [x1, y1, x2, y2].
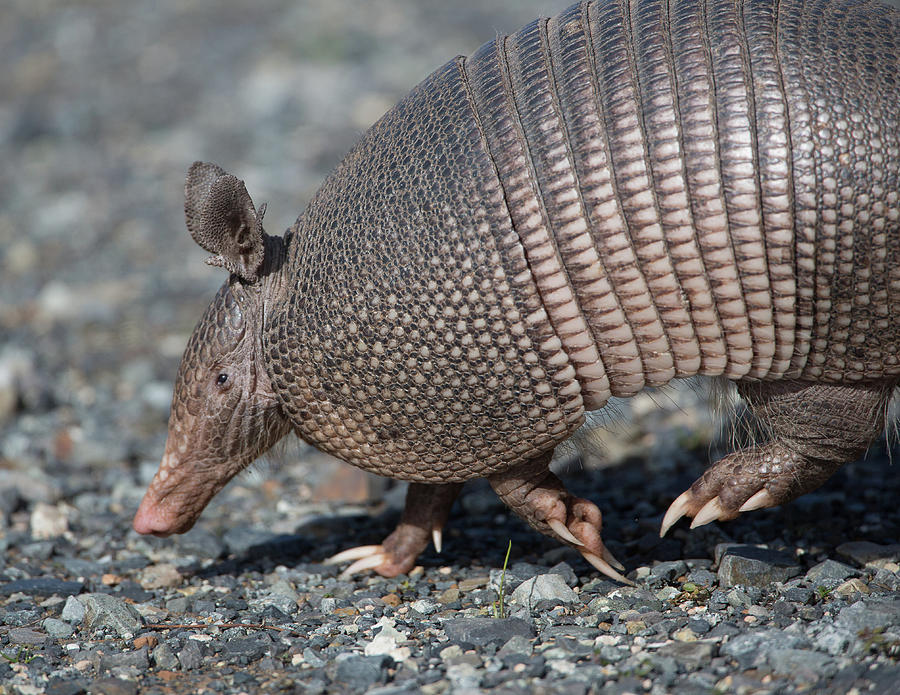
[326, 483, 462, 577]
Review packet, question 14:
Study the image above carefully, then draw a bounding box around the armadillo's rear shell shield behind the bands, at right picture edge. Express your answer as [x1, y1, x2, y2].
[778, 0, 900, 382]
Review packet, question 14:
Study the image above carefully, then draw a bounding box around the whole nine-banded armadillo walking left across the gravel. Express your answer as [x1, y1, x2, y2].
[134, 0, 900, 578]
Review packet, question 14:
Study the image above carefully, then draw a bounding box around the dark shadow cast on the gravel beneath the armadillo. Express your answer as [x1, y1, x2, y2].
[197, 443, 900, 577]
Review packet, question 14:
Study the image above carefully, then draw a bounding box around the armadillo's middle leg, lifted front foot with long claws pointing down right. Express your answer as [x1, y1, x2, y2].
[488, 451, 632, 584]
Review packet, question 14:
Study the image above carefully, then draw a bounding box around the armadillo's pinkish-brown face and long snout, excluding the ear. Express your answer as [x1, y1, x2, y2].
[133, 233, 291, 536]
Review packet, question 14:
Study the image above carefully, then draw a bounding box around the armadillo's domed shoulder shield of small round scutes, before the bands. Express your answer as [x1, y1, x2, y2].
[264, 62, 584, 483]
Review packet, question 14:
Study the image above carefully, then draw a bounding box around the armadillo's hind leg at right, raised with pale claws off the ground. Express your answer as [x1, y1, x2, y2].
[660, 381, 895, 535]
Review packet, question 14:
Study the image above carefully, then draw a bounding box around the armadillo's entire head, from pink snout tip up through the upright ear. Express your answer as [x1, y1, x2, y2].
[133, 163, 290, 536]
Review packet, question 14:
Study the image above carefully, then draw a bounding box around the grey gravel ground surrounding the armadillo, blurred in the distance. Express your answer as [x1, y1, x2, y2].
[0, 0, 900, 695]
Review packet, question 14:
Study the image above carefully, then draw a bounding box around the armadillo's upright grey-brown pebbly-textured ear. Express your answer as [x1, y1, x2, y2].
[184, 162, 266, 282]
